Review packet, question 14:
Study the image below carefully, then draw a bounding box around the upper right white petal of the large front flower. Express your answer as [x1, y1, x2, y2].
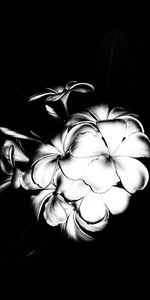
[113, 132, 150, 157]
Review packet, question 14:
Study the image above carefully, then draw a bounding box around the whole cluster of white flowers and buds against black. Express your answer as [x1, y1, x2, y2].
[0, 82, 150, 241]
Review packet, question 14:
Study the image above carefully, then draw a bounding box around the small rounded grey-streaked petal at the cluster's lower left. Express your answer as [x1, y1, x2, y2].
[43, 195, 72, 226]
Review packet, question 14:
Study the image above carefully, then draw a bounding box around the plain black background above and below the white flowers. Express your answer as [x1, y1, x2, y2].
[0, 2, 150, 299]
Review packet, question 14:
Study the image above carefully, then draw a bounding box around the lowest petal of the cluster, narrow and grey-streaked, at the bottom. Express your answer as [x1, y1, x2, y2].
[61, 211, 93, 241]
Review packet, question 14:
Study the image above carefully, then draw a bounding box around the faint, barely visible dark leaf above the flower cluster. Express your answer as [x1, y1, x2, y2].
[93, 31, 127, 102]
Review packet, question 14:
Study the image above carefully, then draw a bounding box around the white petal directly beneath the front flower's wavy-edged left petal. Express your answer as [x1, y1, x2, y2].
[54, 169, 90, 201]
